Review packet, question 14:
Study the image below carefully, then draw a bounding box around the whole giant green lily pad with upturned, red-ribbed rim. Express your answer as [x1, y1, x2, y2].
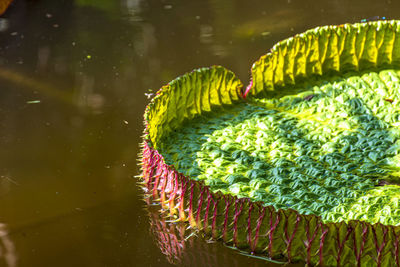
[142, 21, 400, 266]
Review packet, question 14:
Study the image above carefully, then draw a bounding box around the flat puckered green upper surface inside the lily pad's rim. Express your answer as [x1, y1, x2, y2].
[160, 69, 400, 225]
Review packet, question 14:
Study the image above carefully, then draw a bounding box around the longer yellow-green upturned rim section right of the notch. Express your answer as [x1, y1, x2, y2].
[247, 21, 400, 96]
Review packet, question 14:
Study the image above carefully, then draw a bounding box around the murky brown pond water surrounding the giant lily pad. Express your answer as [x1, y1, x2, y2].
[0, 0, 400, 266]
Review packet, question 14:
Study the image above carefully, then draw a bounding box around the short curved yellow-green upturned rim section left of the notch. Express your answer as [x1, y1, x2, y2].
[145, 66, 242, 150]
